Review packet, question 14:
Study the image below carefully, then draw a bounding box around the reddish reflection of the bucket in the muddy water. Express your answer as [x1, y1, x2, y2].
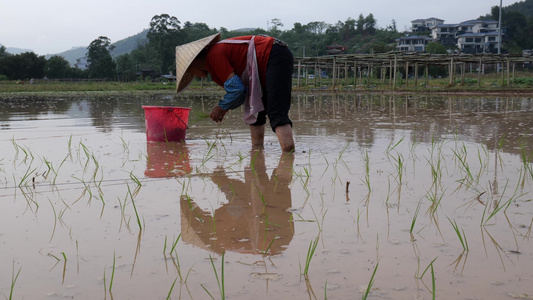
[144, 142, 192, 178]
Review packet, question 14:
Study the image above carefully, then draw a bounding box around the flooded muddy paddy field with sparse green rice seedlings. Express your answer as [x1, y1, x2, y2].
[0, 93, 533, 299]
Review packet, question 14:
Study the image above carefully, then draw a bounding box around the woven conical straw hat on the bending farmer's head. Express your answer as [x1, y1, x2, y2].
[176, 33, 220, 93]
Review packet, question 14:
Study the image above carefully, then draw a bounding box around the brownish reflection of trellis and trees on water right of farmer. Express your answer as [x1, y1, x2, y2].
[291, 92, 533, 153]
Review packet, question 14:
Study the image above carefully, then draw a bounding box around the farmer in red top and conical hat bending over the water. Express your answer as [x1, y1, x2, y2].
[176, 34, 294, 151]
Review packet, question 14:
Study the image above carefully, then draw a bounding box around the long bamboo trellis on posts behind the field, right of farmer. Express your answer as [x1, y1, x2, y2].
[295, 52, 533, 89]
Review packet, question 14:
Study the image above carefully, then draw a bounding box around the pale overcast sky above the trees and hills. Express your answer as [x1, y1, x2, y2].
[0, 0, 508, 55]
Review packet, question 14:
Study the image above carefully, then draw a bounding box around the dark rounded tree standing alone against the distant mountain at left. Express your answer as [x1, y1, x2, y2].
[87, 36, 115, 79]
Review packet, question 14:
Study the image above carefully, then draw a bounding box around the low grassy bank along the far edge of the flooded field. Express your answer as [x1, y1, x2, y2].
[0, 72, 533, 93]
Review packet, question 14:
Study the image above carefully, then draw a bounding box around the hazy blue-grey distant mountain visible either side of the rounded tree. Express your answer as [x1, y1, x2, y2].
[45, 29, 148, 66]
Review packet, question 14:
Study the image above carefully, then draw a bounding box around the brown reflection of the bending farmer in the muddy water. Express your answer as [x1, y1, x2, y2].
[180, 151, 294, 254]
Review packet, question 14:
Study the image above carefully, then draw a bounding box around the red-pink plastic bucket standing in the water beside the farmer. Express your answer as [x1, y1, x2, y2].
[143, 106, 191, 142]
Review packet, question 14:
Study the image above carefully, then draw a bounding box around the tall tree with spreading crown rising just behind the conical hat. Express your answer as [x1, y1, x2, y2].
[146, 14, 185, 73]
